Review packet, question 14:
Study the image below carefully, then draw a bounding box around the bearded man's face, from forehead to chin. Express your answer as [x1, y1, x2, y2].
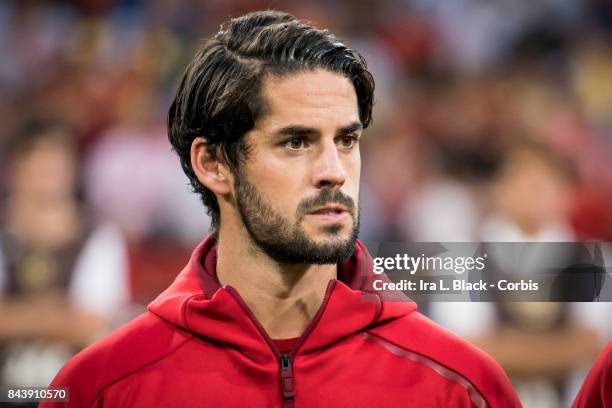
[234, 70, 362, 264]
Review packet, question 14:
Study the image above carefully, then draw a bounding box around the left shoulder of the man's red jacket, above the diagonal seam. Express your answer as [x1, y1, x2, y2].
[45, 312, 193, 407]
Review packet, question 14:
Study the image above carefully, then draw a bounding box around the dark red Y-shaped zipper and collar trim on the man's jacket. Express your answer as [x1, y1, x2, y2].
[225, 279, 337, 408]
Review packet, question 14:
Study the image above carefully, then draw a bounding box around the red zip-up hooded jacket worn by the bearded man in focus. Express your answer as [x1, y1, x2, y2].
[41, 238, 520, 408]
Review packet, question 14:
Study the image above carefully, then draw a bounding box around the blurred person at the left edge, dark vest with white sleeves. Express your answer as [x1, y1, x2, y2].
[0, 120, 130, 386]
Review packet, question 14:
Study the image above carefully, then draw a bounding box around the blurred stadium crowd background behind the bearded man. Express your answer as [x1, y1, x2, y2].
[0, 0, 612, 407]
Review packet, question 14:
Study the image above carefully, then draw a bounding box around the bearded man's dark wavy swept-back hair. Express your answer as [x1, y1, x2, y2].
[168, 10, 374, 232]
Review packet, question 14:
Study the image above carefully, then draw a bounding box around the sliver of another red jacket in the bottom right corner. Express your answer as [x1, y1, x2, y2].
[572, 341, 612, 408]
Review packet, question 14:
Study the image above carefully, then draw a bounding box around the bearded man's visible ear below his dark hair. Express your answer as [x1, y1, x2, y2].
[191, 137, 232, 195]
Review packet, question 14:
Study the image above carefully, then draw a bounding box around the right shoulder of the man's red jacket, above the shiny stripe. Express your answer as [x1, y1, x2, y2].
[369, 312, 521, 407]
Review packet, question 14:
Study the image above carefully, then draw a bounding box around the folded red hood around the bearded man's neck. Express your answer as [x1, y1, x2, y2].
[148, 236, 416, 360]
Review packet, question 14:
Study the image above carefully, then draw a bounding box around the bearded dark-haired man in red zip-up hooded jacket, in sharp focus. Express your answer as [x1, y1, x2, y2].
[43, 11, 520, 407]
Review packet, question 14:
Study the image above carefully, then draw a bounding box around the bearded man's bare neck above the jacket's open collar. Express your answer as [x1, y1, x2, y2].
[217, 227, 337, 339]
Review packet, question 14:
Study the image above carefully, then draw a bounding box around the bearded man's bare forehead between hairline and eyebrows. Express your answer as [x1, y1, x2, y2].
[257, 69, 359, 128]
